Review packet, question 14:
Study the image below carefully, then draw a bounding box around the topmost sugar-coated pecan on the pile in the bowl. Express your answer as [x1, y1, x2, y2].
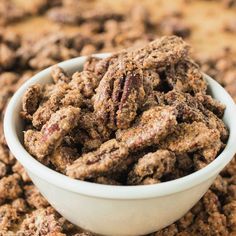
[130, 36, 189, 70]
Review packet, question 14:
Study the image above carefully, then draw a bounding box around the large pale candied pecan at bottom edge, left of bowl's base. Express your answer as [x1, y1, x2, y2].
[17, 207, 63, 236]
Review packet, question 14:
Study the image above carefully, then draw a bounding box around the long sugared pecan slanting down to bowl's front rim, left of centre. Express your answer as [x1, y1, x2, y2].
[66, 139, 128, 180]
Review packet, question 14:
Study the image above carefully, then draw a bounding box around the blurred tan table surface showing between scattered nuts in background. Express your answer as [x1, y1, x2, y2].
[5, 0, 236, 55]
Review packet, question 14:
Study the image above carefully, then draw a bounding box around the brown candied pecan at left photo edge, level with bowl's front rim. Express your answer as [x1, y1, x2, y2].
[0, 174, 22, 204]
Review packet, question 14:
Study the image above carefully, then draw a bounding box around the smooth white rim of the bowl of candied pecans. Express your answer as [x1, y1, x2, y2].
[4, 53, 236, 200]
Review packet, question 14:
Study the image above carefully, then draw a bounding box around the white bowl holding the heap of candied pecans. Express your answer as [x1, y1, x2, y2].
[4, 54, 236, 235]
